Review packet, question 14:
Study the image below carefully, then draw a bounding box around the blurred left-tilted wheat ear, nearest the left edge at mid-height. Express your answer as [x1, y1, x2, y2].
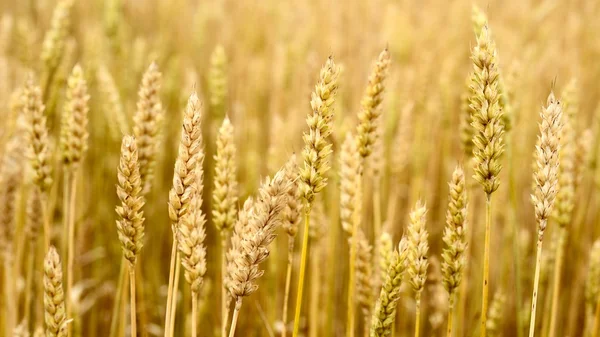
[22, 76, 52, 195]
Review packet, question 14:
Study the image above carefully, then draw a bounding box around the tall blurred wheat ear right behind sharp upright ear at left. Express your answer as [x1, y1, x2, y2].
[133, 63, 164, 194]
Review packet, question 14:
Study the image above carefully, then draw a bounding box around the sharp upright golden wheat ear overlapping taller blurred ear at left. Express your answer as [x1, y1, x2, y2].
[116, 136, 144, 265]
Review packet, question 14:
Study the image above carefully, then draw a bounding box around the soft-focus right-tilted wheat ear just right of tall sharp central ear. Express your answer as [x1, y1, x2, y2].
[356, 48, 390, 158]
